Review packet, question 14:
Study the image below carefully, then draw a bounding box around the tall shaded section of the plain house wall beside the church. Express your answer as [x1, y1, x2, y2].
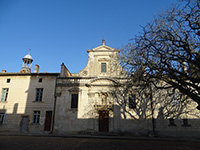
[20, 74, 57, 133]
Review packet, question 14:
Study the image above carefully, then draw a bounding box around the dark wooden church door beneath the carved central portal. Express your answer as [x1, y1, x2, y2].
[99, 110, 109, 132]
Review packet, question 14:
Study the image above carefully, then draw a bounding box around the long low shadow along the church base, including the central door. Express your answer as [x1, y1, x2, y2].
[54, 102, 200, 137]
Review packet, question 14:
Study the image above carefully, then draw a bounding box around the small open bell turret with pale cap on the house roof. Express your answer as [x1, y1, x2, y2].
[20, 53, 33, 73]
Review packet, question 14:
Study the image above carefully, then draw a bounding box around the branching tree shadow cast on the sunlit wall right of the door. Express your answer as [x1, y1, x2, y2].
[110, 78, 200, 135]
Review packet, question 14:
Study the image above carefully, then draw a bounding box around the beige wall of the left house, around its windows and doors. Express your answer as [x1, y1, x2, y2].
[0, 73, 56, 132]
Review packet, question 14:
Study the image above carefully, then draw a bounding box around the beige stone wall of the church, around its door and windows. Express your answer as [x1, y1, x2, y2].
[54, 42, 200, 137]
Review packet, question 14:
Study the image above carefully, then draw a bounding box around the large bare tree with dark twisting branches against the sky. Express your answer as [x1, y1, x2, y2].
[121, 0, 200, 110]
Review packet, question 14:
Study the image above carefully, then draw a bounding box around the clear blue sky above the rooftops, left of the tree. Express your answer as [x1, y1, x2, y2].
[0, 0, 177, 73]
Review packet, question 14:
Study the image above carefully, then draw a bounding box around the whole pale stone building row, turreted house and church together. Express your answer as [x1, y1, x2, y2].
[0, 40, 200, 137]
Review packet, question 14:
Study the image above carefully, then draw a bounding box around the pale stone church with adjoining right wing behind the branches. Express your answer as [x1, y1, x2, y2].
[53, 40, 200, 137]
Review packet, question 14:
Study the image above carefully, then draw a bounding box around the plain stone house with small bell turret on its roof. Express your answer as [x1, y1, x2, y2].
[0, 54, 58, 133]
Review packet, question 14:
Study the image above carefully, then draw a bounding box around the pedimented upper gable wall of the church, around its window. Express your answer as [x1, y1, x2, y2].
[79, 45, 124, 77]
